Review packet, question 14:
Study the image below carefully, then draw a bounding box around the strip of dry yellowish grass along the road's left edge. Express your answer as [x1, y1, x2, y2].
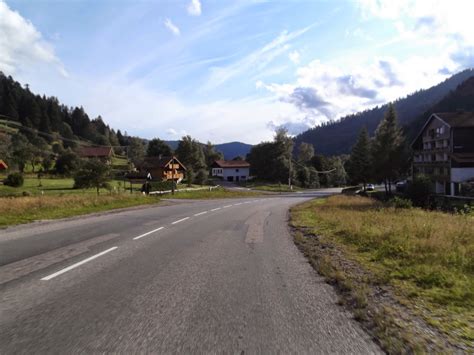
[0, 194, 160, 227]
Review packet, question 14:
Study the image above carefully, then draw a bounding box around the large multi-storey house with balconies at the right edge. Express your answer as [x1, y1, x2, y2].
[412, 111, 474, 196]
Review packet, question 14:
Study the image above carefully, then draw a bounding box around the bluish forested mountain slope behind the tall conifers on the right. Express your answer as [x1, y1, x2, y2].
[295, 69, 474, 156]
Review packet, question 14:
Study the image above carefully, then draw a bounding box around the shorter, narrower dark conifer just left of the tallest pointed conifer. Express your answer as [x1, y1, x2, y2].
[346, 127, 372, 190]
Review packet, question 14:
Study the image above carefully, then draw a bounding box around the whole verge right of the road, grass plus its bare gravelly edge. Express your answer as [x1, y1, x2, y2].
[291, 196, 474, 353]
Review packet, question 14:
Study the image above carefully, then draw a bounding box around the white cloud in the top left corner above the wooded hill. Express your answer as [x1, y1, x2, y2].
[0, 0, 68, 77]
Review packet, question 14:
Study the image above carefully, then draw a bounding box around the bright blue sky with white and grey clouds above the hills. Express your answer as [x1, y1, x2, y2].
[0, 0, 474, 144]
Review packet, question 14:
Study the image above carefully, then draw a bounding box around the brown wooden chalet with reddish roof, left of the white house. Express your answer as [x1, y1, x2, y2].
[138, 156, 186, 183]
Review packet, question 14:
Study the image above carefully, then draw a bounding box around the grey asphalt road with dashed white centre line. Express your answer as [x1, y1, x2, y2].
[0, 193, 380, 354]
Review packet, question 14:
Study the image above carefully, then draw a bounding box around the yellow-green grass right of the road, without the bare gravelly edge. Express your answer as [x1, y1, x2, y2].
[291, 196, 474, 350]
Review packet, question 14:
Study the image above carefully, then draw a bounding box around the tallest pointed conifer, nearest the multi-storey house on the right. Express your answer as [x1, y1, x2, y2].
[372, 103, 404, 194]
